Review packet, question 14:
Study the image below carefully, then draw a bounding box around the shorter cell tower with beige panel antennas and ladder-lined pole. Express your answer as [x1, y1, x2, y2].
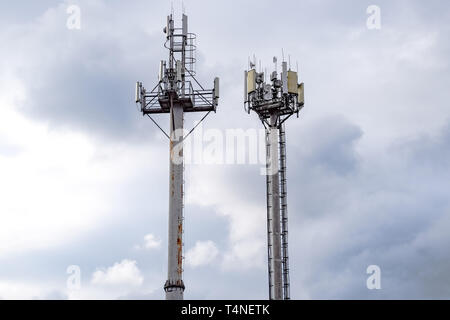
[244, 57, 304, 300]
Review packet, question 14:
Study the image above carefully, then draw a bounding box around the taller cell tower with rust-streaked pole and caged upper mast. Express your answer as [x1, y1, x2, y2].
[136, 13, 219, 300]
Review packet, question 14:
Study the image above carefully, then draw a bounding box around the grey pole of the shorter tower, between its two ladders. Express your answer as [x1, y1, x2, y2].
[269, 112, 283, 300]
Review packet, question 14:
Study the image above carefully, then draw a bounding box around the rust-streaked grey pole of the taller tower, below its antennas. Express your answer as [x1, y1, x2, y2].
[164, 96, 185, 300]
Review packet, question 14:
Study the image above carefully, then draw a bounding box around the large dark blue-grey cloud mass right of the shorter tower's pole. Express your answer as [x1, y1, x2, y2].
[288, 120, 450, 299]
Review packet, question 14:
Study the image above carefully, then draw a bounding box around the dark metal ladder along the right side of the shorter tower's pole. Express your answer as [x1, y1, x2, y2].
[279, 124, 290, 300]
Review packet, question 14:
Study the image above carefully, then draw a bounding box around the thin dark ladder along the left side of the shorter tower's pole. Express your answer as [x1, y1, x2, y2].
[266, 128, 274, 300]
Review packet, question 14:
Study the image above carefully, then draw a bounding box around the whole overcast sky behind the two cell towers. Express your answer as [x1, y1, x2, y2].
[0, 0, 450, 299]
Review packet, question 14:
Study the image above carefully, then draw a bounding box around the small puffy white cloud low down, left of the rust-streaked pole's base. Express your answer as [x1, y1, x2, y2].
[91, 259, 144, 287]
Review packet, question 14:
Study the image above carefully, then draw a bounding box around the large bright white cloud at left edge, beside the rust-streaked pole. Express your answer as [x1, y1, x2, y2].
[0, 91, 168, 256]
